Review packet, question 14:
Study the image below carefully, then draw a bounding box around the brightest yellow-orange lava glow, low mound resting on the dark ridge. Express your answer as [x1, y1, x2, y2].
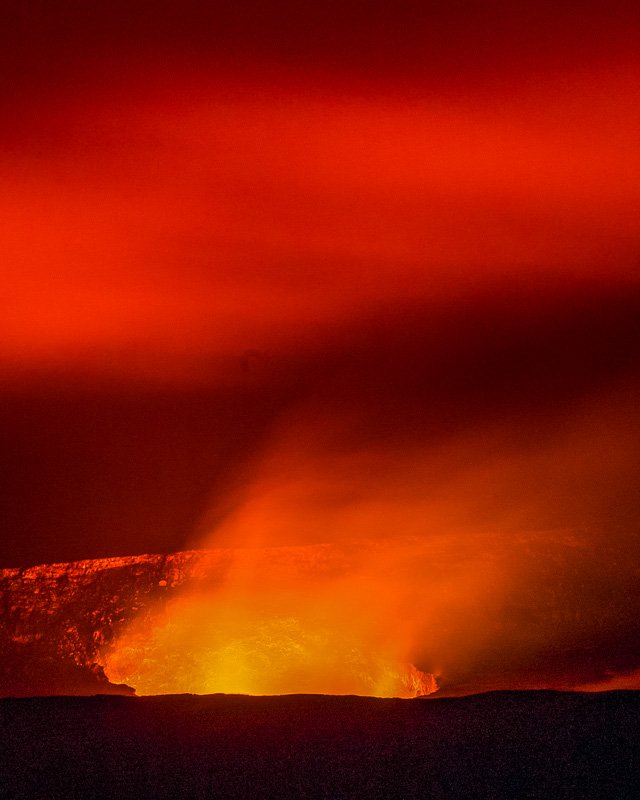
[102, 599, 437, 697]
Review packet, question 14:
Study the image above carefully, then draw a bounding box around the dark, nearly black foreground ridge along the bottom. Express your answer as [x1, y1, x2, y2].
[0, 691, 640, 800]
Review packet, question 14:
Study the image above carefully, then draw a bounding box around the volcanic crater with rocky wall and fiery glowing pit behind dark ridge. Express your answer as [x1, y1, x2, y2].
[0, 531, 637, 698]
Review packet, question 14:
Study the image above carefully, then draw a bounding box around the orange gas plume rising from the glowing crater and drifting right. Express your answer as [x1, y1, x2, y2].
[104, 384, 638, 697]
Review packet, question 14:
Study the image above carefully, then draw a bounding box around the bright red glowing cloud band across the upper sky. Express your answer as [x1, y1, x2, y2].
[0, 66, 640, 379]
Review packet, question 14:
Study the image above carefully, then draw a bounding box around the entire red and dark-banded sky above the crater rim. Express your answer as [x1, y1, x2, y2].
[0, 0, 640, 688]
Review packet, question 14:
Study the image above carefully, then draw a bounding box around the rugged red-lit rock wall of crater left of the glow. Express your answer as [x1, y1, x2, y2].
[0, 551, 210, 696]
